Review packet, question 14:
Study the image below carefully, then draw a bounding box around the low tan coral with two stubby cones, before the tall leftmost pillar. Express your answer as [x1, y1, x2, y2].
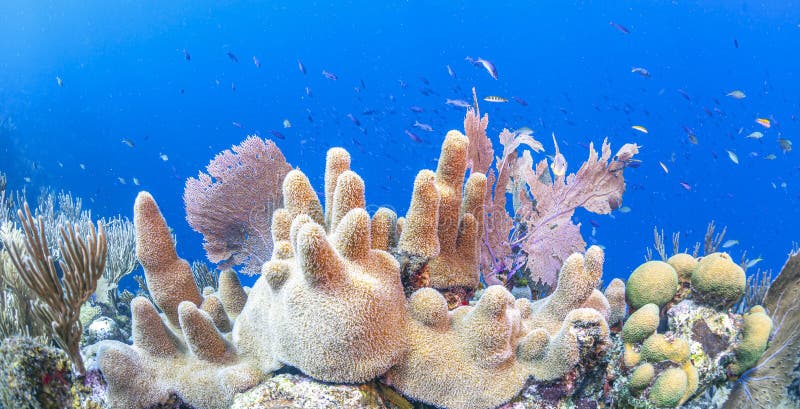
[98, 297, 262, 409]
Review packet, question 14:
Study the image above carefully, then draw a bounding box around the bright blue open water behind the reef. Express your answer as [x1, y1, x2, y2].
[0, 0, 800, 286]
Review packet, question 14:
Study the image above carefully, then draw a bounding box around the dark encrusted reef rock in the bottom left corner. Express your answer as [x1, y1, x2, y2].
[0, 337, 73, 409]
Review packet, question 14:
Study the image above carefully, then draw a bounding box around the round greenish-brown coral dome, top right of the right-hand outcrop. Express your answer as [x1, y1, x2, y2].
[692, 253, 747, 306]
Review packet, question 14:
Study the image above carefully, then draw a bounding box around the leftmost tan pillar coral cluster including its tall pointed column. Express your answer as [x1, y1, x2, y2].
[98, 192, 263, 409]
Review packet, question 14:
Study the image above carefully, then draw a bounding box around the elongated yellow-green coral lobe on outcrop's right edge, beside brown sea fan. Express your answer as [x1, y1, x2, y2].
[730, 305, 772, 375]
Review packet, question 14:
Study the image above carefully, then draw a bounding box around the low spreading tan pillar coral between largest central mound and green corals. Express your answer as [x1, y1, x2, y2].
[387, 246, 609, 409]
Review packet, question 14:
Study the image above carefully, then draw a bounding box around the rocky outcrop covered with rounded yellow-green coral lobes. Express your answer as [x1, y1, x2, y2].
[609, 253, 771, 408]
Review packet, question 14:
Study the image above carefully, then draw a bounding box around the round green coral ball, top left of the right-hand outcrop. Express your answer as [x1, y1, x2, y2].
[625, 261, 678, 310]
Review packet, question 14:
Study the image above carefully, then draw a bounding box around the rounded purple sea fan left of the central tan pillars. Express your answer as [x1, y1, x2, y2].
[183, 136, 292, 275]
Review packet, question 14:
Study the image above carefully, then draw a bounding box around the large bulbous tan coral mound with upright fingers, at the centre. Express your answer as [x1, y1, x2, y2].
[233, 149, 406, 382]
